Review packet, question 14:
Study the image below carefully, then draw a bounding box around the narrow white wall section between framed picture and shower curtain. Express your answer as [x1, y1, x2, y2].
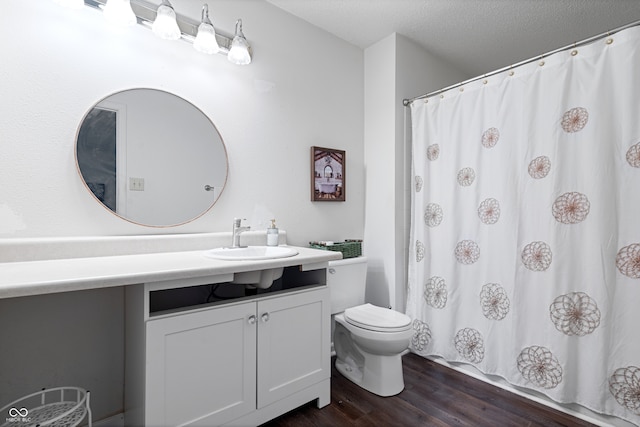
[364, 34, 470, 311]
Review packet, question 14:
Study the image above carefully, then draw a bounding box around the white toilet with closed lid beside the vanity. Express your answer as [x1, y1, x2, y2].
[327, 257, 413, 396]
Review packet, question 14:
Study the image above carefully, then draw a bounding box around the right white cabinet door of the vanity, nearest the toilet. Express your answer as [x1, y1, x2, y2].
[258, 287, 331, 408]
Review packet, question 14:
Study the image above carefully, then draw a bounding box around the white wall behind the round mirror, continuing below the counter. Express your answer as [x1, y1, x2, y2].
[0, 0, 364, 419]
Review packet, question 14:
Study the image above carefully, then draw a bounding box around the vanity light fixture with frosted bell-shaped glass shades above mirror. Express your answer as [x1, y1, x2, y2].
[67, 0, 252, 65]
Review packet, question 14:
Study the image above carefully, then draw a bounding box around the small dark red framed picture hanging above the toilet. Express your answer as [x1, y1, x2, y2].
[311, 147, 346, 202]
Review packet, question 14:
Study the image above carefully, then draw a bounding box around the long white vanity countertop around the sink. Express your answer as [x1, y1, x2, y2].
[0, 246, 342, 298]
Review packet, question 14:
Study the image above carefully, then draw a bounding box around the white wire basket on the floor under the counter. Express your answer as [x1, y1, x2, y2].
[0, 387, 91, 427]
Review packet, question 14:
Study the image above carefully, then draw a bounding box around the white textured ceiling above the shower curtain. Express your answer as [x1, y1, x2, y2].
[267, 0, 640, 77]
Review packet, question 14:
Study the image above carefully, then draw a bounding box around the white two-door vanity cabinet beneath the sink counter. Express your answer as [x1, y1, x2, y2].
[125, 276, 331, 427]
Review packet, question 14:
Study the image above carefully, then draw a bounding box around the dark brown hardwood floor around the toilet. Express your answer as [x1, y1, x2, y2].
[263, 353, 593, 427]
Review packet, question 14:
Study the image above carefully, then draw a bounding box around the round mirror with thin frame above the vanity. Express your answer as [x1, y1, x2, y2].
[76, 89, 228, 227]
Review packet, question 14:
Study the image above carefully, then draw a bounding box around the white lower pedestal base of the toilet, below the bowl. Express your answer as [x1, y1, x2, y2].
[336, 354, 404, 397]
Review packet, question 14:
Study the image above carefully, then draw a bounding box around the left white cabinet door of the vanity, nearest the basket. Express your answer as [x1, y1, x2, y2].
[145, 302, 256, 426]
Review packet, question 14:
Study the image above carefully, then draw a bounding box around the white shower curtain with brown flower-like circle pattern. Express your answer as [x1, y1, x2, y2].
[406, 27, 640, 425]
